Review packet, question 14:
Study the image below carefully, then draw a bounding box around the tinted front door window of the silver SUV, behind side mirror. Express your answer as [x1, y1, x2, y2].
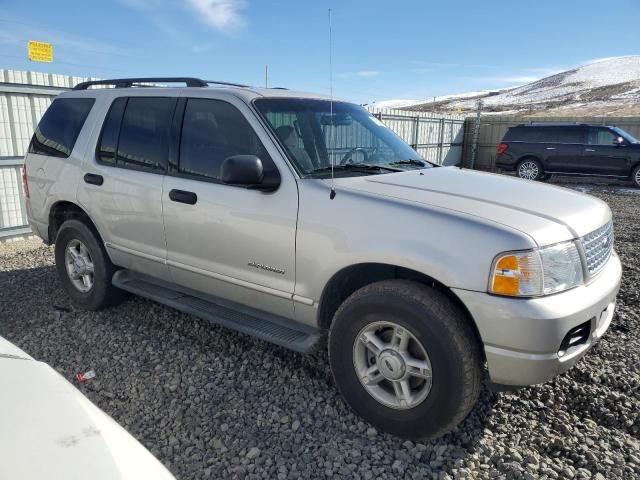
[180, 98, 271, 180]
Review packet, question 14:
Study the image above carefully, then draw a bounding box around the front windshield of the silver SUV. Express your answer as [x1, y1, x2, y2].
[255, 98, 430, 178]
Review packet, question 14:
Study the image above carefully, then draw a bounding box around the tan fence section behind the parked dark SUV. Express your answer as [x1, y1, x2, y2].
[464, 115, 640, 171]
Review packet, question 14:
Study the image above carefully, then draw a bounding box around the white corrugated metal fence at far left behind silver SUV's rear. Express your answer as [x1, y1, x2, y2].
[0, 70, 88, 237]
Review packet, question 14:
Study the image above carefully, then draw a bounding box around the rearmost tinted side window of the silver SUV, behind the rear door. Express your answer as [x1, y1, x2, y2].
[29, 98, 94, 157]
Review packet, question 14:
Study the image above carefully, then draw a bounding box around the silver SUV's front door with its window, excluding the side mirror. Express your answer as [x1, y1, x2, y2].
[162, 98, 298, 318]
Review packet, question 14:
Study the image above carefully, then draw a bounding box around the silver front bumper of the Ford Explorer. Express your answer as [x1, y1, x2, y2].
[454, 252, 622, 386]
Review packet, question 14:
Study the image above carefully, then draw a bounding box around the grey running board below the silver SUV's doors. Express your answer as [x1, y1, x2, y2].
[111, 270, 323, 353]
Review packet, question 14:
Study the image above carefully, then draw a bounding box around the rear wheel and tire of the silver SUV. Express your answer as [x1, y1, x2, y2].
[55, 220, 126, 310]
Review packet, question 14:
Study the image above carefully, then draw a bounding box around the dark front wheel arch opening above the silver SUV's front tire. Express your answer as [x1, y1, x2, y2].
[318, 263, 484, 352]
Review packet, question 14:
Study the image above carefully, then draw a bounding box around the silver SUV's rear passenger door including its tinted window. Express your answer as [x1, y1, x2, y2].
[78, 96, 177, 277]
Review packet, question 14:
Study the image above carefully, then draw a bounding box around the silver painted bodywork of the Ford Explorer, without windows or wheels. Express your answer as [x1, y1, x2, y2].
[26, 88, 621, 385]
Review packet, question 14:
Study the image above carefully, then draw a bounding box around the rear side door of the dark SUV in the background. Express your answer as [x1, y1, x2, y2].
[538, 125, 586, 173]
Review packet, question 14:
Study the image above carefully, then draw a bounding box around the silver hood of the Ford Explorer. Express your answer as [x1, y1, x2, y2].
[335, 167, 611, 246]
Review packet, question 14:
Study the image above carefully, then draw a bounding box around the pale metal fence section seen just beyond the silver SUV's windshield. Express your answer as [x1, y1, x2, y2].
[367, 105, 465, 165]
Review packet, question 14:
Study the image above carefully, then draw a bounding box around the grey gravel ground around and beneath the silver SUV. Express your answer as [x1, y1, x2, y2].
[0, 186, 640, 479]
